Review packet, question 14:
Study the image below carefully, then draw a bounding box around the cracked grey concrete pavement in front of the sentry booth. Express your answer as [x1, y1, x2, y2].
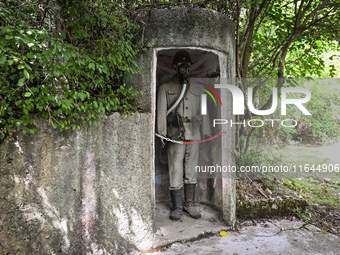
[151, 220, 340, 255]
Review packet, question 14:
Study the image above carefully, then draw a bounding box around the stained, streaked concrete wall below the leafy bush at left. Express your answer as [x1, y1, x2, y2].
[0, 113, 154, 254]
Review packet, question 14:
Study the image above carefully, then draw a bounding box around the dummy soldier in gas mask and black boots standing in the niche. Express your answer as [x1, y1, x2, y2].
[157, 50, 210, 220]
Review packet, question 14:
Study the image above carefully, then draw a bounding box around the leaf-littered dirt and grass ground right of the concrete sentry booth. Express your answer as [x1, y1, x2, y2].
[237, 143, 340, 236]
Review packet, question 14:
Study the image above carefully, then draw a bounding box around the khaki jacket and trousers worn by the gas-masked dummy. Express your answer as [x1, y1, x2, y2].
[157, 77, 210, 190]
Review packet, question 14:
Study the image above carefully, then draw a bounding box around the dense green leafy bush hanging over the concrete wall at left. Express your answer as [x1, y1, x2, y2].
[0, 0, 138, 141]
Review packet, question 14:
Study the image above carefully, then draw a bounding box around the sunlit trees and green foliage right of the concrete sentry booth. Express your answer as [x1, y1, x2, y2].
[228, 0, 340, 157]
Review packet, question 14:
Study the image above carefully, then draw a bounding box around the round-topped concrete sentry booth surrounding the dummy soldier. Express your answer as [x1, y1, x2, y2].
[134, 8, 235, 239]
